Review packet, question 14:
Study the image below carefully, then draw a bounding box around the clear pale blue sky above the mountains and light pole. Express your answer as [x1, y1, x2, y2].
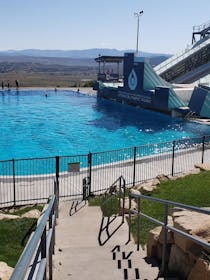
[0, 0, 210, 53]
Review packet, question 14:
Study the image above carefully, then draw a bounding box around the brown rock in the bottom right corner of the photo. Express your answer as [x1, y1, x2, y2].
[188, 258, 210, 280]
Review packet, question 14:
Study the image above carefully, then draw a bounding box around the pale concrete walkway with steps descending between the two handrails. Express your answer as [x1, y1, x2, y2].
[53, 202, 158, 280]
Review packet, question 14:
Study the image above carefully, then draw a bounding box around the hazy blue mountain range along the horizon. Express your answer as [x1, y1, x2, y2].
[0, 48, 171, 58]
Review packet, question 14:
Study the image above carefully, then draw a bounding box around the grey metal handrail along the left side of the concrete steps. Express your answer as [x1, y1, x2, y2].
[10, 195, 56, 280]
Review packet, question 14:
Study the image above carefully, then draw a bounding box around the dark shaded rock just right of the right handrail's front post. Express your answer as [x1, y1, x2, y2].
[168, 244, 195, 279]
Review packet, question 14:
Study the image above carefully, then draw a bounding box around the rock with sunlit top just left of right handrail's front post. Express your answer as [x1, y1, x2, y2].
[147, 226, 162, 258]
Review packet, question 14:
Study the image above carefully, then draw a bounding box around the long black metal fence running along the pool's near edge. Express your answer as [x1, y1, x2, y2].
[0, 136, 210, 207]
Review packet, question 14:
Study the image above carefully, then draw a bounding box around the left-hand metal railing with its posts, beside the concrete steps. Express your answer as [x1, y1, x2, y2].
[10, 195, 58, 280]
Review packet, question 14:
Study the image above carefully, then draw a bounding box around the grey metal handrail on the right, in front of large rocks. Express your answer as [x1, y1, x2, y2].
[128, 192, 210, 275]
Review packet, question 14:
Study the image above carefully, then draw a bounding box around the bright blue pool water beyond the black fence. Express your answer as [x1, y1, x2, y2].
[0, 90, 210, 160]
